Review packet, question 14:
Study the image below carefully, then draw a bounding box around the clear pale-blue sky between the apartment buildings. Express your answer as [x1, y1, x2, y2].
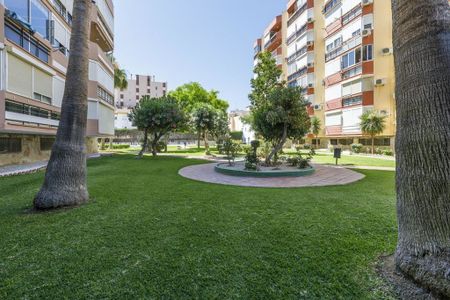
[114, 0, 287, 109]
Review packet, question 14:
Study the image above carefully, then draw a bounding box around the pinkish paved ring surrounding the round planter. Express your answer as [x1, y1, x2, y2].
[178, 164, 365, 188]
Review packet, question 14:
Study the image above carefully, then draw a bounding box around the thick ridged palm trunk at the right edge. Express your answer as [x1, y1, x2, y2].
[392, 0, 450, 299]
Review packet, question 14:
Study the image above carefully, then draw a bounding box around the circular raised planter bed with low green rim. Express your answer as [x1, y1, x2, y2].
[214, 162, 315, 178]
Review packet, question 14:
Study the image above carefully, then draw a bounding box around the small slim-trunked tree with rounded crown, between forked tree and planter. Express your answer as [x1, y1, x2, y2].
[192, 103, 218, 153]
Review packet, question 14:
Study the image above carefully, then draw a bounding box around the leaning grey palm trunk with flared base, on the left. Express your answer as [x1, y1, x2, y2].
[34, 0, 92, 209]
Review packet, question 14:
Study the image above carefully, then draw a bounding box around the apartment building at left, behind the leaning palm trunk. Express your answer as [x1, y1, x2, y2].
[0, 0, 114, 165]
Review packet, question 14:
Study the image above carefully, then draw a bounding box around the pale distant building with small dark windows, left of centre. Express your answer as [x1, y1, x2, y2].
[114, 75, 168, 129]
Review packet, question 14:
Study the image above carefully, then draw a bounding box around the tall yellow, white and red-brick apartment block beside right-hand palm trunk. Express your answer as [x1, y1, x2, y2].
[255, 0, 396, 148]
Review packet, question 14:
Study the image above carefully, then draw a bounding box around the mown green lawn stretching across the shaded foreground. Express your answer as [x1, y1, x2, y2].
[0, 155, 397, 299]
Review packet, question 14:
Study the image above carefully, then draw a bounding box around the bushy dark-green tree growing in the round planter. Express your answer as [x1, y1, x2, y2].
[252, 86, 311, 165]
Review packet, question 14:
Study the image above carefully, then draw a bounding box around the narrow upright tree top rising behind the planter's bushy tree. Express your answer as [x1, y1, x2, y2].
[249, 51, 282, 108]
